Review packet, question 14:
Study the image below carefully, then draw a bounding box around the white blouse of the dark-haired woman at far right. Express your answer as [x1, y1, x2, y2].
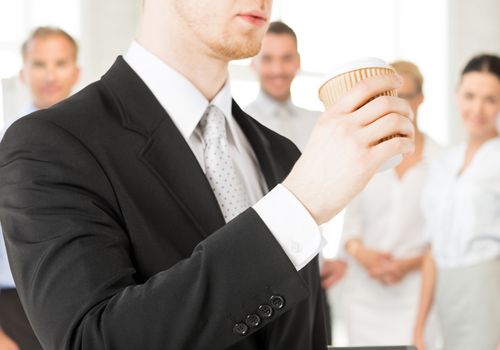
[422, 137, 500, 268]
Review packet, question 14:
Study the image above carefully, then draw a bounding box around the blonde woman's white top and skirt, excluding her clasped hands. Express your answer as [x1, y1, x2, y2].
[336, 137, 440, 345]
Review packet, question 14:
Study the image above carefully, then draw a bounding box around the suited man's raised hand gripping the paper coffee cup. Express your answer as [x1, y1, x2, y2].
[283, 59, 415, 224]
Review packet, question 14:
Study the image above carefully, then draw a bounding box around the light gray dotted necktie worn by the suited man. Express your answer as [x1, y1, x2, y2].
[200, 105, 250, 222]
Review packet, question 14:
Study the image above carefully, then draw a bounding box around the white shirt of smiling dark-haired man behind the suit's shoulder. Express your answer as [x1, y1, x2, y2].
[245, 91, 320, 150]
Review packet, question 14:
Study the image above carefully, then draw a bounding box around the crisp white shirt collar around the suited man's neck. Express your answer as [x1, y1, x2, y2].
[124, 41, 234, 142]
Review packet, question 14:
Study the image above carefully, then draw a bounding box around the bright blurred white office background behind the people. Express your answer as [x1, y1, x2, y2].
[0, 0, 500, 342]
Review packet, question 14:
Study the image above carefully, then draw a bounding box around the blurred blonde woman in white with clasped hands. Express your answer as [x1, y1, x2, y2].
[339, 61, 439, 345]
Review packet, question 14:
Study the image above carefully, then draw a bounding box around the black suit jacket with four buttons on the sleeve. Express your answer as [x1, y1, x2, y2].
[0, 58, 326, 350]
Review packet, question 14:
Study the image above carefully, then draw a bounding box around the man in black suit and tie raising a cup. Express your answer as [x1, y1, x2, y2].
[0, 0, 413, 350]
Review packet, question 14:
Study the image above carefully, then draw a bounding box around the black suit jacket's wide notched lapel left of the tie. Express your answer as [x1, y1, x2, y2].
[102, 57, 225, 237]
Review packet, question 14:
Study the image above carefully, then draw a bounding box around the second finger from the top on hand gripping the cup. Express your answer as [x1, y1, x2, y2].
[353, 96, 414, 126]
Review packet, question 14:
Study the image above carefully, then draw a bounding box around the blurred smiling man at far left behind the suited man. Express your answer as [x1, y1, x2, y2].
[0, 27, 80, 350]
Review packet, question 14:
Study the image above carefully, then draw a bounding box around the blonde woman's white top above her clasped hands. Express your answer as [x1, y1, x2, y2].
[342, 137, 440, 258]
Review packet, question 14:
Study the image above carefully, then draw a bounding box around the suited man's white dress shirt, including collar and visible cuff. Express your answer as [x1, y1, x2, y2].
[124, 42, 322, 270]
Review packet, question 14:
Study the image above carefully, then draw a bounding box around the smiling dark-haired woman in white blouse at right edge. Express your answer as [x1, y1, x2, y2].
[415, 55, 500, 350]
